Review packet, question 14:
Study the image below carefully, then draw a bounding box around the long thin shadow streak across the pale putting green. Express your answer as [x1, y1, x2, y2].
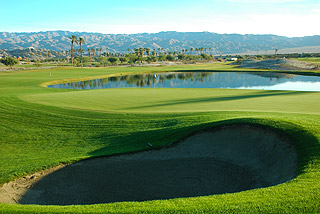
[121, 91, 312, 110]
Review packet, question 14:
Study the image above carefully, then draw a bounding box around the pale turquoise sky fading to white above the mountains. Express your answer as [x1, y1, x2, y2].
[0, 0, 320, 37]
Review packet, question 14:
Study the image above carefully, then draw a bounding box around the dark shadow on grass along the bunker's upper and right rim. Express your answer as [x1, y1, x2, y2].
[89, 117, 320, 174]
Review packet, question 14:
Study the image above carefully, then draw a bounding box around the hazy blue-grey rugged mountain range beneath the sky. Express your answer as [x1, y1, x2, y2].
[0, 31, 320, 54]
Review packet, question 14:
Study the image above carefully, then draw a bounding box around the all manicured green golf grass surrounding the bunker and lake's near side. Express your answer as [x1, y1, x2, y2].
[0, 64, 320, 213]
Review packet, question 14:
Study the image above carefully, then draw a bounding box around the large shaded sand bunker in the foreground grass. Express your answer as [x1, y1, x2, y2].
[0, 125, 297, 205]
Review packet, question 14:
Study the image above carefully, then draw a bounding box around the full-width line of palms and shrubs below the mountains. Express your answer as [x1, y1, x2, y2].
[2, 35, 320, 66]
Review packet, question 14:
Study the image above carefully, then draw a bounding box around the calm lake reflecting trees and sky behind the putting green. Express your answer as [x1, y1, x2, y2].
[48, 72, 320, 91]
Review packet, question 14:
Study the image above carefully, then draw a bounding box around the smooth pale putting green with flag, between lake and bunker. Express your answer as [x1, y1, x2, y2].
[20, 88, 320, 114]
